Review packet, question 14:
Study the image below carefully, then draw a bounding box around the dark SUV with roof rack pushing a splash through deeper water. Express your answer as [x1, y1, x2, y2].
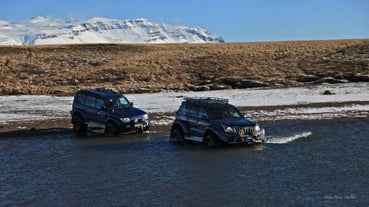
[170, 98, 265, 146]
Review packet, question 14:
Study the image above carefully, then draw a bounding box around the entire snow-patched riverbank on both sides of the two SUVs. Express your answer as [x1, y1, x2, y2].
[0, 83, 369, 124]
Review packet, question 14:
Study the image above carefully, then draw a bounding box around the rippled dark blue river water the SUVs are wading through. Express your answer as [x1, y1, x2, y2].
[0, 119, 369, 206]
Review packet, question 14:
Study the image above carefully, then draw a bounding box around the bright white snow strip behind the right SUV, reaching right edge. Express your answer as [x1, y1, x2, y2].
[127, 83, 369, 112]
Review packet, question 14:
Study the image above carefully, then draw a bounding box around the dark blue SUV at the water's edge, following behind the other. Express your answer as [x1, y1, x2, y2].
[71, 88, 150, 136]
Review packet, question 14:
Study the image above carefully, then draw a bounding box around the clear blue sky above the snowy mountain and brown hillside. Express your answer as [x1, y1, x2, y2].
[0, 0, 369, 42]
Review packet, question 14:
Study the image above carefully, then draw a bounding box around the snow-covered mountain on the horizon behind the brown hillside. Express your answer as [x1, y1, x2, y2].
[0, 17, 224, 45]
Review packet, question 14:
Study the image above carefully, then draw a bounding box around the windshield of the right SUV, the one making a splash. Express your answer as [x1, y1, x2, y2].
[209, 105, 243, 119]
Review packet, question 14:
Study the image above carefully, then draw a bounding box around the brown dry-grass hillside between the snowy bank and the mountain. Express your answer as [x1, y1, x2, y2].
[0, 39, 369, 95]
